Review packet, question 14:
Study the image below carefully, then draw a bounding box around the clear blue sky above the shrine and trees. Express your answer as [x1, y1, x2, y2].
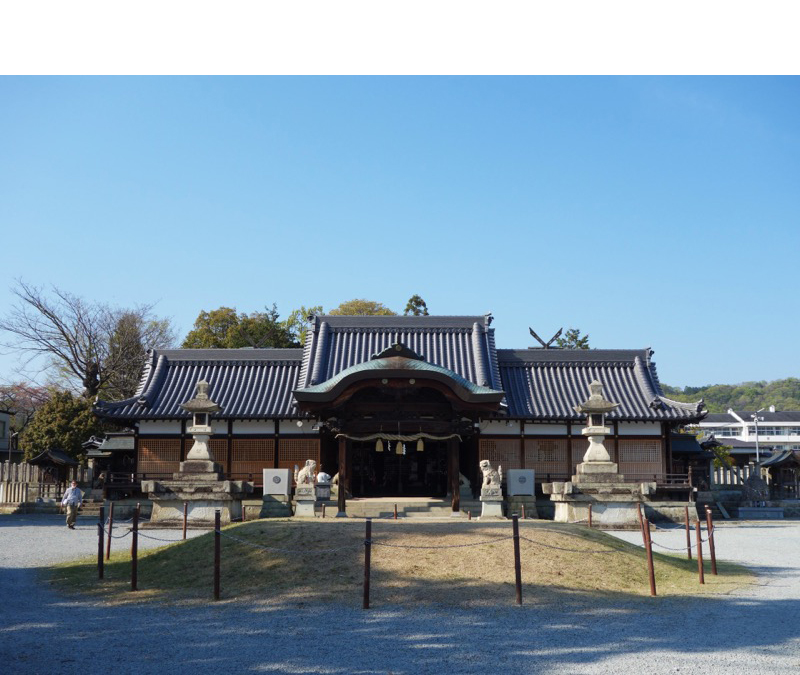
[0, 77, 800, 386]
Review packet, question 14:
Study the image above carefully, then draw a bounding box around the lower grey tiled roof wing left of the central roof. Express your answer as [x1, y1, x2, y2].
[95, 349, 302, 420]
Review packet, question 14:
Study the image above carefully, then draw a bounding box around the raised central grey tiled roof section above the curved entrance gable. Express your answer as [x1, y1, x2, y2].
[299, 315, 502, 389]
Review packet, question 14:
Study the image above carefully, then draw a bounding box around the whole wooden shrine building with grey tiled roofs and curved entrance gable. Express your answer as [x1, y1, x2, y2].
[95, 315, 706, 510]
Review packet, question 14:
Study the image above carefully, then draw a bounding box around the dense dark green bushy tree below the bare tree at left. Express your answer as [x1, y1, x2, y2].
[20, 391, 102, 459]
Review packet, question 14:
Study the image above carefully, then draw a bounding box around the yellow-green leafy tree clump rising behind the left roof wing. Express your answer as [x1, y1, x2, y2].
[181, 304, 298, 349]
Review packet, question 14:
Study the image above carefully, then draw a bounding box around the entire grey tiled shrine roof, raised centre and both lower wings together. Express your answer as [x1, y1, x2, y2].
[95, 316, 704, 423]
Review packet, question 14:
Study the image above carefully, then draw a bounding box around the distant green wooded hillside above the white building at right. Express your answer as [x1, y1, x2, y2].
[661, 377, 800, 412]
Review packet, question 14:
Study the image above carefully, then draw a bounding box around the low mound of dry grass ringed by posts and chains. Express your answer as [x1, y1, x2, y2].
[49, 519, 752, 606]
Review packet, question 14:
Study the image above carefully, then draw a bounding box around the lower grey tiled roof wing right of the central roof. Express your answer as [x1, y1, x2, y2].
[497, 349, 703, 423]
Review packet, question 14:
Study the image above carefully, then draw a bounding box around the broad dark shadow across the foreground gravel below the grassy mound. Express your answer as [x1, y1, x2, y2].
[0, 570, 800, 674]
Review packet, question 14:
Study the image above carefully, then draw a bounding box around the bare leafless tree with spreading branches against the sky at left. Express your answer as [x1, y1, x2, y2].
[0, 280, 171, 398]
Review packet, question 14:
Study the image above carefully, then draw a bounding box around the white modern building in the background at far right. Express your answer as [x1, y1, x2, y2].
[697, 405, 800, 450]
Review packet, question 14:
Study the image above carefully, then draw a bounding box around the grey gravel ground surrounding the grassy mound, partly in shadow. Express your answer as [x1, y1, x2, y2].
[0, 515, 800, 675]
